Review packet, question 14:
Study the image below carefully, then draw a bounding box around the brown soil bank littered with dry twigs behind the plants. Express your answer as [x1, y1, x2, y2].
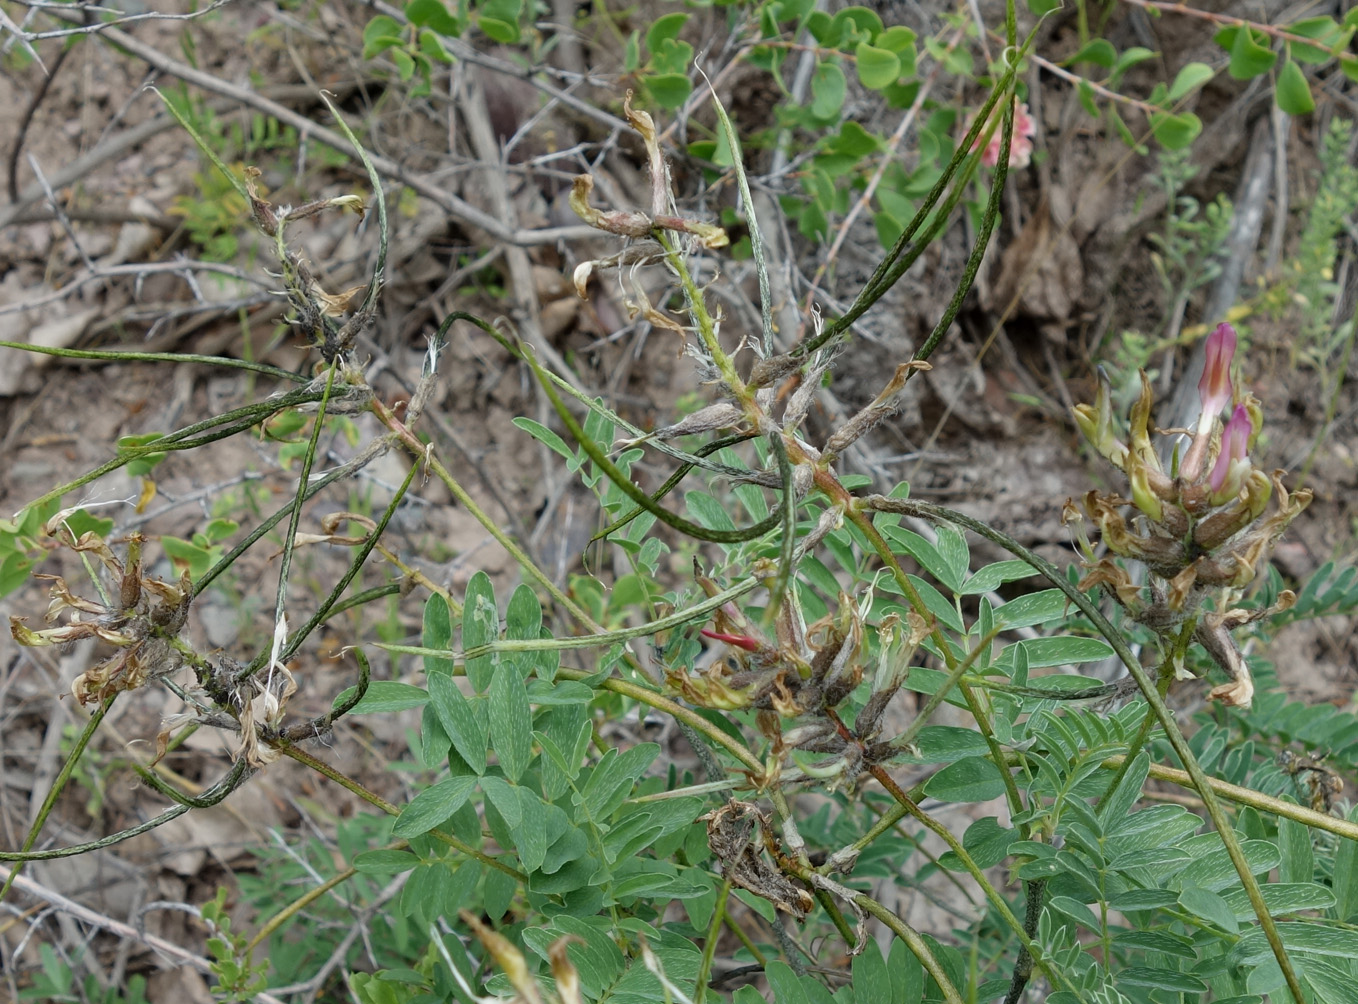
[0, 3, 1358, 1001]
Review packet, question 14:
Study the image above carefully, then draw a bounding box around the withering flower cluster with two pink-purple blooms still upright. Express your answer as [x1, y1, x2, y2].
[1065, 323, 1310, 708]
